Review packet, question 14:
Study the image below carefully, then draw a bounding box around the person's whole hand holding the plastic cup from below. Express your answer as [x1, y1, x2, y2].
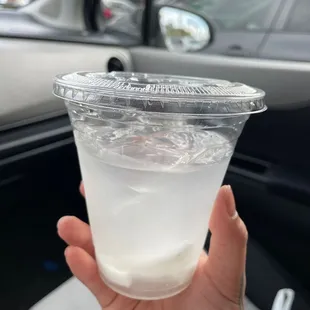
[58, 185, 247, 310]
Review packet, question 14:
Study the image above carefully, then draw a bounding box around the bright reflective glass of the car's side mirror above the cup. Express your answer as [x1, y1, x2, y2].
[158, 6, 213, 52]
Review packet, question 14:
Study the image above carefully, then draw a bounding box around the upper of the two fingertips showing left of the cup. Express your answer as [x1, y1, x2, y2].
[57, 216, 95, 257]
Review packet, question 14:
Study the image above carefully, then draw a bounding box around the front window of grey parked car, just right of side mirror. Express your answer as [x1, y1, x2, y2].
[168, 0, 279, 31]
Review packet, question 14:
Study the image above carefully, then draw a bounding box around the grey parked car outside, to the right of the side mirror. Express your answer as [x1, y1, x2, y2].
[185, 0, 310, 61]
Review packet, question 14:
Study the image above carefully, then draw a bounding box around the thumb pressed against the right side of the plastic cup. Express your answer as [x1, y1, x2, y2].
[207, 186, 248, 304]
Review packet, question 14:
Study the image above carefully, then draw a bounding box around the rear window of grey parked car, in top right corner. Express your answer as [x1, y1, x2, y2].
[284, 0, 310, 33]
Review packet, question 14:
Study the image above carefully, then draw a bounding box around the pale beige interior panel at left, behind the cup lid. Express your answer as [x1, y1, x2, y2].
[0, 38, 132, 129]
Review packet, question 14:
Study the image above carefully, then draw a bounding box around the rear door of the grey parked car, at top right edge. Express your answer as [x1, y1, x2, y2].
[260, 0, 310, 61]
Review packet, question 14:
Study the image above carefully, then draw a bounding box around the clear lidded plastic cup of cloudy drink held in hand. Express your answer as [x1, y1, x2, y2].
[54, 72, 266, 300]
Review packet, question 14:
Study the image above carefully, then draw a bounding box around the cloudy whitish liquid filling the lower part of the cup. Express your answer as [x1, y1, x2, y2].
[76, 124, 232, 299]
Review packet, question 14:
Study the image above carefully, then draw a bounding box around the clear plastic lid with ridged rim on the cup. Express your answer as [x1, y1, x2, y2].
[54, 72, 266, 116]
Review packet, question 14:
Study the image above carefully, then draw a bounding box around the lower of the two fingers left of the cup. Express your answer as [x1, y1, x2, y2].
[65, 246, 117, 309]
